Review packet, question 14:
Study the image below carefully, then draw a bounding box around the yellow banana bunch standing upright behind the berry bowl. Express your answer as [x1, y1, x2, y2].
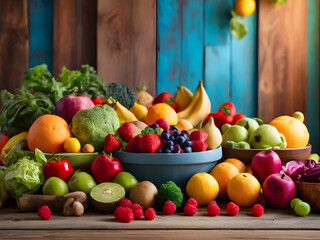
[177, 80, 211, 126]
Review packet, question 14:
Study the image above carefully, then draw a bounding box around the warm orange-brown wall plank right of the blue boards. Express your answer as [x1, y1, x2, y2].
[258, 0, 307, 123]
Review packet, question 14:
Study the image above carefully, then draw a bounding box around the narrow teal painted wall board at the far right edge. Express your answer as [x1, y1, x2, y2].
[307, 0, 320, 154]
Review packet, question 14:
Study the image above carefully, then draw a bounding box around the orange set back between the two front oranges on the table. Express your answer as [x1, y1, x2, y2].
[210, 162, 239, 200]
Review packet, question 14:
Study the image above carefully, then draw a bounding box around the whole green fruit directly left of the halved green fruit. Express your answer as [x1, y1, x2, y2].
[68, 172, 97, 195]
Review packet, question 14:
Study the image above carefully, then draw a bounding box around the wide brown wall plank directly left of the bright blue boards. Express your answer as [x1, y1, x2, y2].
[97, 0, 156, 95]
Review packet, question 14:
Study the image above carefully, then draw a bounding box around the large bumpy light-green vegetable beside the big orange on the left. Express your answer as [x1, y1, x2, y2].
[71, 104, 120, 151]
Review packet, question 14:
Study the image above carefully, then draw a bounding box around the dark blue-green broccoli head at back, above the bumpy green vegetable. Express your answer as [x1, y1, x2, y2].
[107, 83, 137, 109]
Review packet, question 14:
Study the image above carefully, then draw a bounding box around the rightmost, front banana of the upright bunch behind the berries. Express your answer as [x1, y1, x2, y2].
[184, 80, 211, 126]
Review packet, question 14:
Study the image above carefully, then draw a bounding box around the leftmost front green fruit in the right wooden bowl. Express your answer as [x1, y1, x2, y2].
[222, 124, 249, 146]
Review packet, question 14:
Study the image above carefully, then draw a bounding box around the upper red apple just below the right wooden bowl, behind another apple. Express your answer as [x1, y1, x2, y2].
[251, 150, 282, 183]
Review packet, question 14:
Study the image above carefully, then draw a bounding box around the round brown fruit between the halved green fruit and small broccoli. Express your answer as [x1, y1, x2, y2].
[129, 181, 158, 209]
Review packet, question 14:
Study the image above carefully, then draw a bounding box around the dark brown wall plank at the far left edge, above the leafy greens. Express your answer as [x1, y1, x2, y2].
[0, 0, 29, 92]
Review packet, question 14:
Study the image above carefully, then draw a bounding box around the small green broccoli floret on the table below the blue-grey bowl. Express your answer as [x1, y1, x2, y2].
[157, 181, 183, 207]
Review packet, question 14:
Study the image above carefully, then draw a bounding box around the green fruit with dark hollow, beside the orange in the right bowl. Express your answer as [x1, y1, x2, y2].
[249, 124, 287, 149]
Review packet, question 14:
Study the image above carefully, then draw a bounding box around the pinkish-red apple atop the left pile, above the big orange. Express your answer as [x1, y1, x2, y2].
[56, 94, 94, 123]
